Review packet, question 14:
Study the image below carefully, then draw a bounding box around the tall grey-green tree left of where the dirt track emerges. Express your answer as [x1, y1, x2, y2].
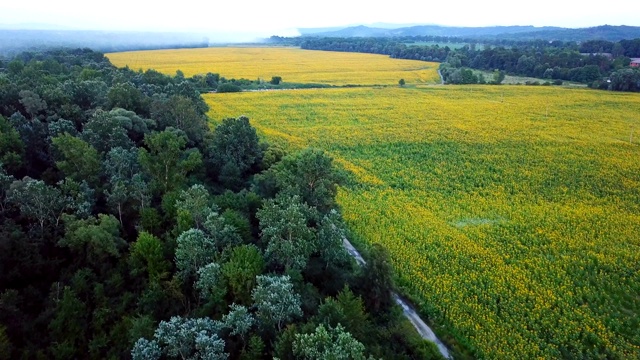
[256, 195, 316, 270]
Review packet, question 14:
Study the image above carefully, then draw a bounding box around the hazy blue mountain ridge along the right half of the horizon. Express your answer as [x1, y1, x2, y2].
[301, 25, 640, 41]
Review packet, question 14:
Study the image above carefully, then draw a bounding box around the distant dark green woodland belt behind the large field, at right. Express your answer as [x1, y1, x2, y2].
[296, 37, 640, 91]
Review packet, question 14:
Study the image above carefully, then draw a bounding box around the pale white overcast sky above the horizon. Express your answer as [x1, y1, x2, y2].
[0, 0, 640, 37]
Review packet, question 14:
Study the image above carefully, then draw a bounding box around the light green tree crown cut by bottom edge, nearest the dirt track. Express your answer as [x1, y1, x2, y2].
[293, 324, 365, 360]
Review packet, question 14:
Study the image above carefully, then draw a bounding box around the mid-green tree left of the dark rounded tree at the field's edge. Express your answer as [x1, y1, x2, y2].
[138, 128, 202, 194]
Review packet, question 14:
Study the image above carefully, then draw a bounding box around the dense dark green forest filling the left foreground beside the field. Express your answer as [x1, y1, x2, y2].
[0, 49, 439, 359]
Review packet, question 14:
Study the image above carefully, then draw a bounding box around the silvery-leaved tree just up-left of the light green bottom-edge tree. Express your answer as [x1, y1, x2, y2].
[251, 275, 302, 332]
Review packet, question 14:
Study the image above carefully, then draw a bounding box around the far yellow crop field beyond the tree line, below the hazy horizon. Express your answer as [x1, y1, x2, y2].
[106, 47, 440, 85]
